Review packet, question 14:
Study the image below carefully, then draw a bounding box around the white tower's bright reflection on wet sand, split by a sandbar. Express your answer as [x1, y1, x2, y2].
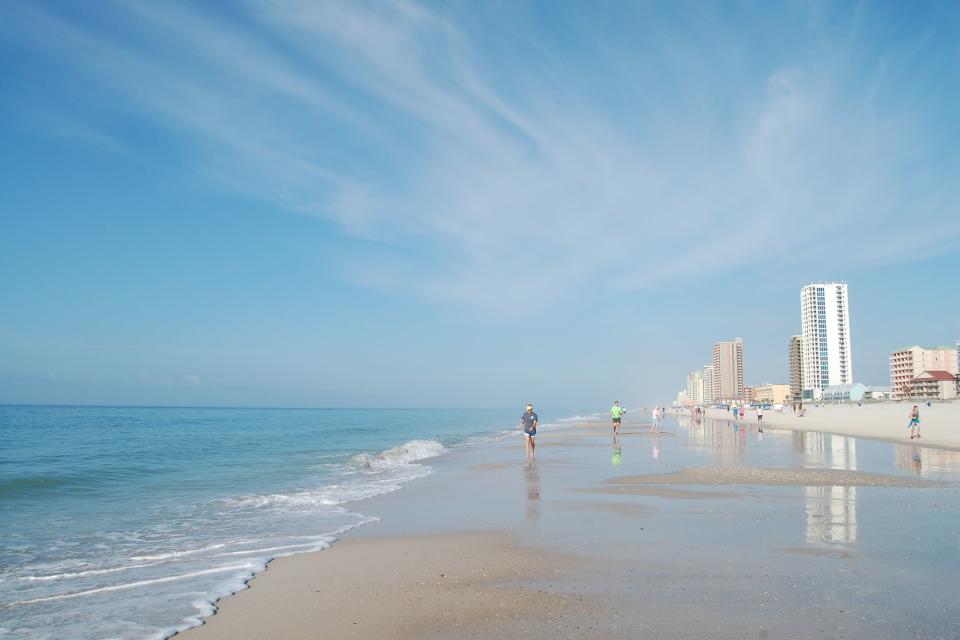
[793, 433, 857, 544]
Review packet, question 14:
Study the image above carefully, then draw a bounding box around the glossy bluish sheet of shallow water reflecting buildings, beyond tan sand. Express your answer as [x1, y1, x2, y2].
[358, 417, 960, 640]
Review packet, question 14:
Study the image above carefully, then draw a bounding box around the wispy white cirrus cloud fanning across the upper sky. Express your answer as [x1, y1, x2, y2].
[3, 0, 960, 308]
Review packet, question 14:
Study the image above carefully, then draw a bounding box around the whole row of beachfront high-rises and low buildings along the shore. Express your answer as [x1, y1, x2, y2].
[674, 282, 960, 407]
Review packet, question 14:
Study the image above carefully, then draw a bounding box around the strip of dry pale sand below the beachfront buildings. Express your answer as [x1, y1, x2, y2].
[696, 402, 960, 450]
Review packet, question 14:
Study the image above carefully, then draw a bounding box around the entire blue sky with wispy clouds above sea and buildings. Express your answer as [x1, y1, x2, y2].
[0, 0, 960, 414]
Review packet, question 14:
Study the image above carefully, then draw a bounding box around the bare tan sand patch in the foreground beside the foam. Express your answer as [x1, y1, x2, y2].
[176, 533, 587, 640]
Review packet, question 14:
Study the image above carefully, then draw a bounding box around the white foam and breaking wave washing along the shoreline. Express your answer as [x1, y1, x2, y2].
[2, 440, 458, 640]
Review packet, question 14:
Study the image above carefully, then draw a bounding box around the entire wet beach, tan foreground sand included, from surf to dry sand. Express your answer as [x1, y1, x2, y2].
[182, 407, 960, 640]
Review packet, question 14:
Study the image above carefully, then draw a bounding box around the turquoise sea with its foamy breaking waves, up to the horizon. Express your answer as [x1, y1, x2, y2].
[0, 406, 574, 640]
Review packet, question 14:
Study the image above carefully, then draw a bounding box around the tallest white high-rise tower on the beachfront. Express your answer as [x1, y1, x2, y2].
[800, 282, 853, 400]
